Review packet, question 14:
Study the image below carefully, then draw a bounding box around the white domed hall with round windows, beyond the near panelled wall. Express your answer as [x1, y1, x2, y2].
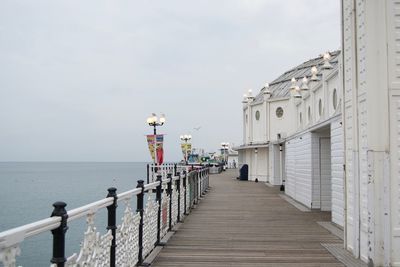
[238, 51, 344, 227]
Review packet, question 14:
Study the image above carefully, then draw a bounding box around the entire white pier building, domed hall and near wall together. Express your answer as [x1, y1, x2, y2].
[238, 0, 400, 266]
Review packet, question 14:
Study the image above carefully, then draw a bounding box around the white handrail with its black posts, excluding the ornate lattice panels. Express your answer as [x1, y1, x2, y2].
[0, 164, 208, 266]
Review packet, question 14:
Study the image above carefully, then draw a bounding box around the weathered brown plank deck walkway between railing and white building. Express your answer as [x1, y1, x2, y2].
[152, 171, 343, 267]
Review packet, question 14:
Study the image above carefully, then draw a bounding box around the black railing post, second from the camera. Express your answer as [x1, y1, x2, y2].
[107, 187, 118, 267]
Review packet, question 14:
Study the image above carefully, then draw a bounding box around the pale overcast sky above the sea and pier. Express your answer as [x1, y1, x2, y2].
[0, 0, 340, 161]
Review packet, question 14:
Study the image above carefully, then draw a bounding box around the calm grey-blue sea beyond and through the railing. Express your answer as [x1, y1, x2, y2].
[0, 162, 147, 267]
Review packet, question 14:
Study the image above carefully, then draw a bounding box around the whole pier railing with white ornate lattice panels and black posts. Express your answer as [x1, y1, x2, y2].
[0, 168, 208, 267]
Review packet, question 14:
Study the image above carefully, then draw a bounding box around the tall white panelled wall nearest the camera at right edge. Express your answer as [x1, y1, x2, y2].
[342, 0, 400, 266]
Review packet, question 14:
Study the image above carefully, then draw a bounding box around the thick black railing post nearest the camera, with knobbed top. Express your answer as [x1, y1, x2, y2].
[51, 201, 68, 267]
